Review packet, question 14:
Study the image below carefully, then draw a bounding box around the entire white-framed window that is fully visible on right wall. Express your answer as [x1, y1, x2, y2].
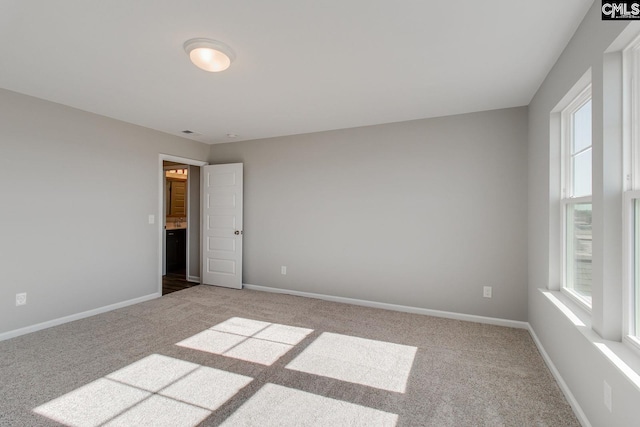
[561, 86, 593, 308]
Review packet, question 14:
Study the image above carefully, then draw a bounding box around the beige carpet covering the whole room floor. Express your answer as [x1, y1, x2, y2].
[0, 286, 579, 427]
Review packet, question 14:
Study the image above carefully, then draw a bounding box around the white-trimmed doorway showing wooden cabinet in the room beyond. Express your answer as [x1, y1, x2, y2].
[158, 154, 206, 295]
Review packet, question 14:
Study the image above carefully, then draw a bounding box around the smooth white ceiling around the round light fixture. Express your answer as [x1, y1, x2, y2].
[0, 0, 593, 143]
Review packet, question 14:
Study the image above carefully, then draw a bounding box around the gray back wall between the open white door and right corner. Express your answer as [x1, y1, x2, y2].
[209, 108, 527, 320]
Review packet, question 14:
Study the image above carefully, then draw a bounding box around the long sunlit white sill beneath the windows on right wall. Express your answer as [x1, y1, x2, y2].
[539, 289, 640, 390]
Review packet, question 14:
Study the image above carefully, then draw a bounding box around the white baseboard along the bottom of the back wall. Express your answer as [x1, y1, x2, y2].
[242, 283, 529, 329]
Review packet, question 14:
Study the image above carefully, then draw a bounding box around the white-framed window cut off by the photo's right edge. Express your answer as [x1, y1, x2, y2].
[622, 37, 640, 351]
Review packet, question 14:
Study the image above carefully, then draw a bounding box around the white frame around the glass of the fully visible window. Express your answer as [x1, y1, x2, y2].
[560, 81, 593, 313]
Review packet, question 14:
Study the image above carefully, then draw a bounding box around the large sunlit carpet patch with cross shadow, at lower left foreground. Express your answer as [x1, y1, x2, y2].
[34, 354, 252, 427]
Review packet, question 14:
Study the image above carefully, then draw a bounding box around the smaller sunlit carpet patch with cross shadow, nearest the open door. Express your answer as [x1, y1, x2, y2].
[176, 317, 313, 365]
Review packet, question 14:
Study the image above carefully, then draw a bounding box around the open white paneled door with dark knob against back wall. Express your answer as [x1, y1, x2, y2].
[201, 163, 242, 289]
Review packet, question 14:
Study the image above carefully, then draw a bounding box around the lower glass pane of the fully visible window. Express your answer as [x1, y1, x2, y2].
[565, 203, 592, 304]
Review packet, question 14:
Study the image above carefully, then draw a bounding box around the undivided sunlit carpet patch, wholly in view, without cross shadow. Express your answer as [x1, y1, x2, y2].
[287, 332, 417, 393]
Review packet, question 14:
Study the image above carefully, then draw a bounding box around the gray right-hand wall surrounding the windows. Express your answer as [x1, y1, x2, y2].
[528, 2, 640, 426]
